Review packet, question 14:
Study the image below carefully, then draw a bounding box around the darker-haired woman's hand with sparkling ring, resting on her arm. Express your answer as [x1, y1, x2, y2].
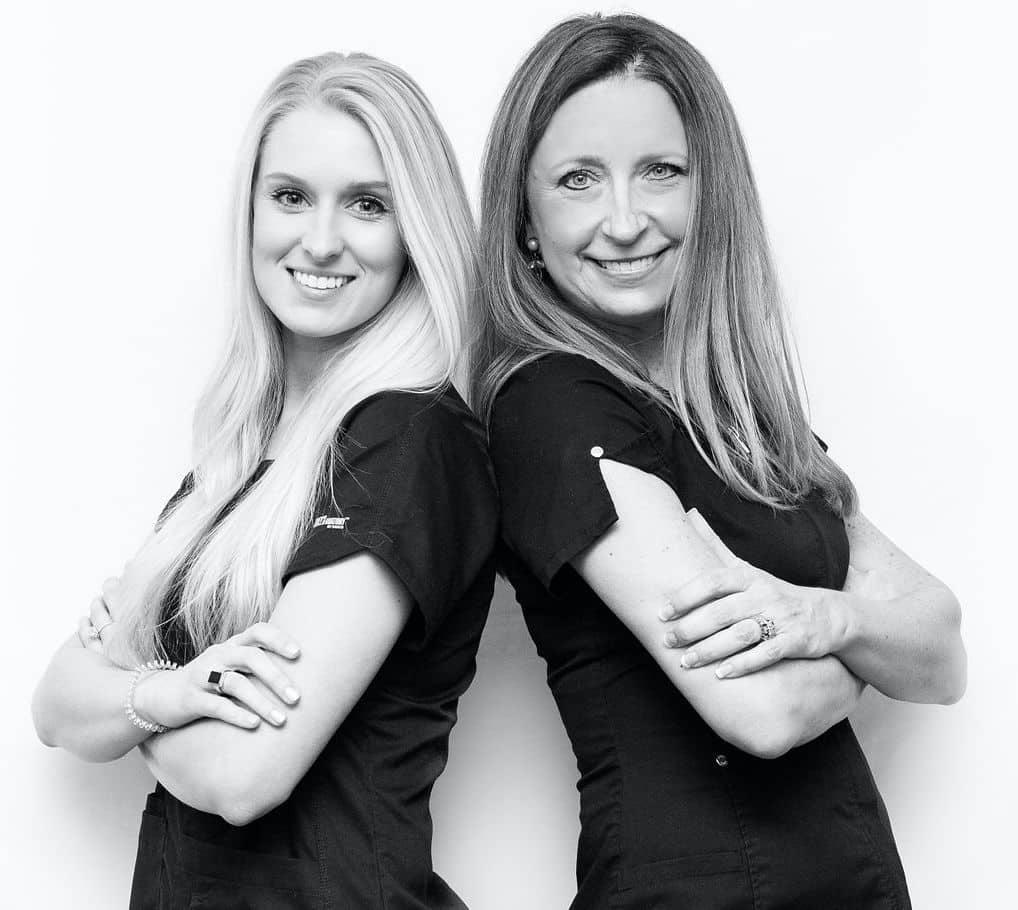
[661, 509, 840, 678]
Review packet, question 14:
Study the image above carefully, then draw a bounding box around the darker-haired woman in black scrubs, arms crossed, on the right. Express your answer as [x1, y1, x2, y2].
[477, 15, 965, 910]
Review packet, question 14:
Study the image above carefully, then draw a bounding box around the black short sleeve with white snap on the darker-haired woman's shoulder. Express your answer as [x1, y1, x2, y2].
[490, 354, 675, 588]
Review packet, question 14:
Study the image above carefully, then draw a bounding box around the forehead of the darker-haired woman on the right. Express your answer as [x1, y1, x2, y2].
[533, 76, 687, 166]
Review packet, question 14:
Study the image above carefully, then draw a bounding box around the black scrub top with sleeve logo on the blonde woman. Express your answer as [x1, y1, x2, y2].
[130, 389, 498, 910]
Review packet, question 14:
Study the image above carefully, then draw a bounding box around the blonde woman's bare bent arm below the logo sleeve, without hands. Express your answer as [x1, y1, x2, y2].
[142, 552, 413, 824]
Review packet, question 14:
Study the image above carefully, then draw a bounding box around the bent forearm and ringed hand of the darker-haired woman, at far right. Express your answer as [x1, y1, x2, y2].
[666, 514, 965, 704]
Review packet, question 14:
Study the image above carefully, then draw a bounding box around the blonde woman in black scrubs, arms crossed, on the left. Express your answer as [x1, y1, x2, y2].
[34, 54, 497, 908]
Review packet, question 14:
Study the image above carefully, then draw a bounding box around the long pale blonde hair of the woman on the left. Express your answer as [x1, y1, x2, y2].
[111, 54, 475, 660]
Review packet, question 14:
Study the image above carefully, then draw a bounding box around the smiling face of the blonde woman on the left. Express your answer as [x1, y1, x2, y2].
[251, 107, 407, 343]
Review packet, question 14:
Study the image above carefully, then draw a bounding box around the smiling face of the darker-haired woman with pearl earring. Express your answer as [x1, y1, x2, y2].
[526, 76, 690, 333]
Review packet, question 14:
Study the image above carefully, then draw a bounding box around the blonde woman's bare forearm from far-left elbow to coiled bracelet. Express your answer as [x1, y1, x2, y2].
[32, 639, 151, 761]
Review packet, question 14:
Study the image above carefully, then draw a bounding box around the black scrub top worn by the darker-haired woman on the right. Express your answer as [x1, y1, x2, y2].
[490, 354, 909, 910]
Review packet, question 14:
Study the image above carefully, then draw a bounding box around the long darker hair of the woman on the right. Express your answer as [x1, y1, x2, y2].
[474, 14, 855, 514]
